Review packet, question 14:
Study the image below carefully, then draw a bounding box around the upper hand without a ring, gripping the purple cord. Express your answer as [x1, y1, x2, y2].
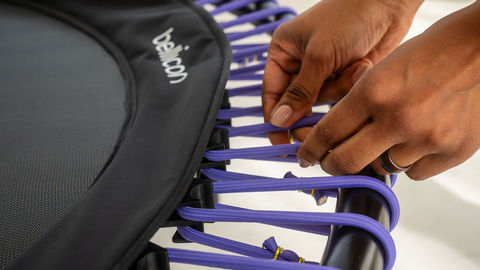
[262, 0, 423, 144]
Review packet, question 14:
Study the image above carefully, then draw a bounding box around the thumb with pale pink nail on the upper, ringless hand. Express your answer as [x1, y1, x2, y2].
[270, 57, 331, 127]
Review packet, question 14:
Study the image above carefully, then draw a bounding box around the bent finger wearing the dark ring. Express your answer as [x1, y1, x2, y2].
[371, 143, 425, 175]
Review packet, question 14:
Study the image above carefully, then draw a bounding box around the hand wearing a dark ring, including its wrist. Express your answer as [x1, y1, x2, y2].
[297, 1, 480, 180]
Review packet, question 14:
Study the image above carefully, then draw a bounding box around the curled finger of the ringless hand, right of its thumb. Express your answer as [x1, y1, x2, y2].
[317, 58, 373, 104]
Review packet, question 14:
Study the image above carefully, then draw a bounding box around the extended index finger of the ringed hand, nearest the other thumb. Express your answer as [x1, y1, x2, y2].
[297, 90, 372, 167]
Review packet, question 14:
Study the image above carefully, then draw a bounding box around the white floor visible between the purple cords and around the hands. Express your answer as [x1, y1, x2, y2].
[153, 0, 480, 270]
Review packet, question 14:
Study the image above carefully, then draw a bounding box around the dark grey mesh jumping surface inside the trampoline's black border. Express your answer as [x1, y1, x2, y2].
[0, 4, 126, 268]
